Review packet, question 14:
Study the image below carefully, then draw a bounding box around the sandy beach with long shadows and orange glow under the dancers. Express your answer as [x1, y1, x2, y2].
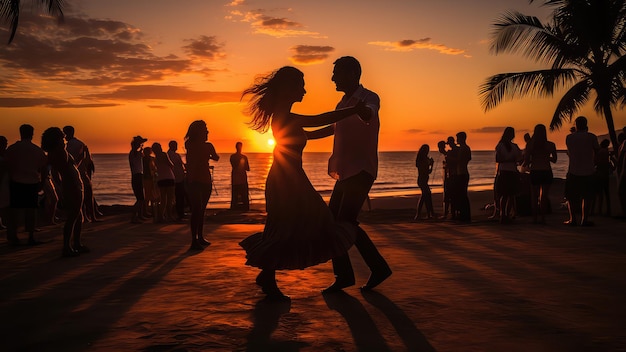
[0, 182, 626, 351]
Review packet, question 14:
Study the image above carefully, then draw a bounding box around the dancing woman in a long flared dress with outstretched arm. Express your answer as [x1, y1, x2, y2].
[240, 67, 365, 299]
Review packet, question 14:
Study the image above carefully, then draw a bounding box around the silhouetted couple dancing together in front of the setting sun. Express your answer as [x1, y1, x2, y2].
[240, 57, 391, 300]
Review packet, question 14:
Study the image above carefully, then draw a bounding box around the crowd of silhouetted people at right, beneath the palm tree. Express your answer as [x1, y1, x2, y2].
[414, 116, 626, 226]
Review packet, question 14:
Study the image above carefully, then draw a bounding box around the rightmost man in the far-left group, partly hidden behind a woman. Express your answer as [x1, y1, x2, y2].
[63, 126, 98, 222]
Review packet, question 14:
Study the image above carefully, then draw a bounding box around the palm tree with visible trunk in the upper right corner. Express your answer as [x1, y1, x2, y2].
[479, 0, 626, 150]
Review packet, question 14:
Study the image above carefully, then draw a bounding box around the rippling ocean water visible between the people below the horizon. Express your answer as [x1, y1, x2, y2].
[93, 151, 568, 207]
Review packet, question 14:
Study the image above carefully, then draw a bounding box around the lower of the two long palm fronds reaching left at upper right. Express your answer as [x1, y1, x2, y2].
[478, 69, 577, 111]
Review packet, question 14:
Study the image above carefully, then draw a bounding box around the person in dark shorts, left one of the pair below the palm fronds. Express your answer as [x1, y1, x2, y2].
[496, 127, 522, 223]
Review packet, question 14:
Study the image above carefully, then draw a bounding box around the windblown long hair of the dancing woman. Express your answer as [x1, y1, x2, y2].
[241, 66, 304, 133]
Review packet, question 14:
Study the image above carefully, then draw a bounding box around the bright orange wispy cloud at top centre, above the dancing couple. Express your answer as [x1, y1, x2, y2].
[227, 9, 326, 38]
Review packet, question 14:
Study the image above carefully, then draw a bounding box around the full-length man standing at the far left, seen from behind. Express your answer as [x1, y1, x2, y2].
[5, 124, 48, 245]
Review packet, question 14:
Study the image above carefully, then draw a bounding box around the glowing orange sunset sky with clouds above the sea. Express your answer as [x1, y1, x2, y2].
[0, 0, 626, 153]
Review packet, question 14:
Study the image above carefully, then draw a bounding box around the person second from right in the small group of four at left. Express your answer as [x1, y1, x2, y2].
[152, 142, 175, 222]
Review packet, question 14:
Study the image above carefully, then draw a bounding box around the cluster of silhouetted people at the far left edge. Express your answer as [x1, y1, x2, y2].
[0, 124, 102, 257]
